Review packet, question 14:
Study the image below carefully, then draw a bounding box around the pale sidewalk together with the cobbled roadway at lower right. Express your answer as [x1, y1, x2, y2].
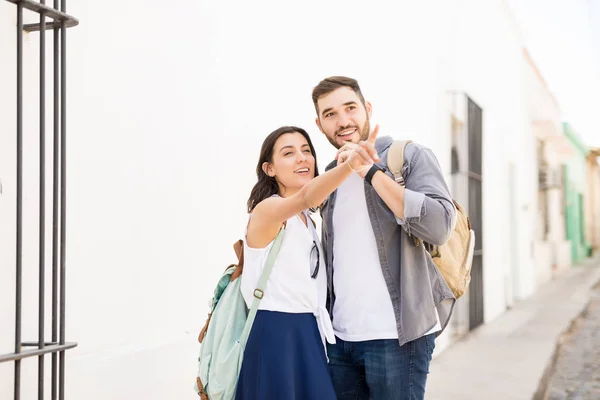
[425, 257, 600, 400]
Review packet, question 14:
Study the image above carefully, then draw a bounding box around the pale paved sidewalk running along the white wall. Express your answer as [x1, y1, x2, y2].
[425, 258, 600, 400]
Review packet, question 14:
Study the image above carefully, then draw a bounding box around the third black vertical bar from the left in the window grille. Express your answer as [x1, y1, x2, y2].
[51, 0, 60, 394]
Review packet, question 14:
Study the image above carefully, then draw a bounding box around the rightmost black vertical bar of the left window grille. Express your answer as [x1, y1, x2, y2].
[58, 0, 67, 400]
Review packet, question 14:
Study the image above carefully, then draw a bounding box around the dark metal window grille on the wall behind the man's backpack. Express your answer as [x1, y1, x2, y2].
[467, 98, 484, 329]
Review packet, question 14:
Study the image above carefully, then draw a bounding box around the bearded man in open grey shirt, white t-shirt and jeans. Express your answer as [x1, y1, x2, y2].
[312, 76, 456, 400]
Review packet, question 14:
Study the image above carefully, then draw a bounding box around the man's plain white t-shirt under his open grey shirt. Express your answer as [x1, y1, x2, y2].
[333, 173, 441, 342]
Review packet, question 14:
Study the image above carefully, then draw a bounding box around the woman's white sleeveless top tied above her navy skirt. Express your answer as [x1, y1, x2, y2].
[241, 212, 335, 343]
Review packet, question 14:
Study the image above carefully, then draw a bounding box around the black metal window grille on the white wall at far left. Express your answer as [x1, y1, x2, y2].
[0, 0, 78, 400]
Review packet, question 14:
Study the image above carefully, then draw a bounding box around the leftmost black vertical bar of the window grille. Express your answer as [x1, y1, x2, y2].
[14, 3, 23, 400]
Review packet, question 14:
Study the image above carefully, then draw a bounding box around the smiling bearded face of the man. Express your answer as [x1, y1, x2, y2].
[316, 86, 371, 149]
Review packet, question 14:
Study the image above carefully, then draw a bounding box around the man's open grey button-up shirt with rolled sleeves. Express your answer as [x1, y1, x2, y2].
[322, 137, 456, 345]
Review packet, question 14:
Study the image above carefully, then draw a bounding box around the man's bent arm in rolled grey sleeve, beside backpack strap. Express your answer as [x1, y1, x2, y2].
[361, 148, 456, 245]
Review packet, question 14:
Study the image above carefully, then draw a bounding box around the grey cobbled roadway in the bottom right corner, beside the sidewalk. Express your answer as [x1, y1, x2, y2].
[546, 283, 600, 400]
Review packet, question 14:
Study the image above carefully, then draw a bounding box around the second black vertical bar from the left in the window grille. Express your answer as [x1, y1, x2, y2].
[38, 0, 46, 400]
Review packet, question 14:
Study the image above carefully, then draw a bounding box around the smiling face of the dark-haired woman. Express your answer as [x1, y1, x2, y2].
[263, 132, 315, 196]
